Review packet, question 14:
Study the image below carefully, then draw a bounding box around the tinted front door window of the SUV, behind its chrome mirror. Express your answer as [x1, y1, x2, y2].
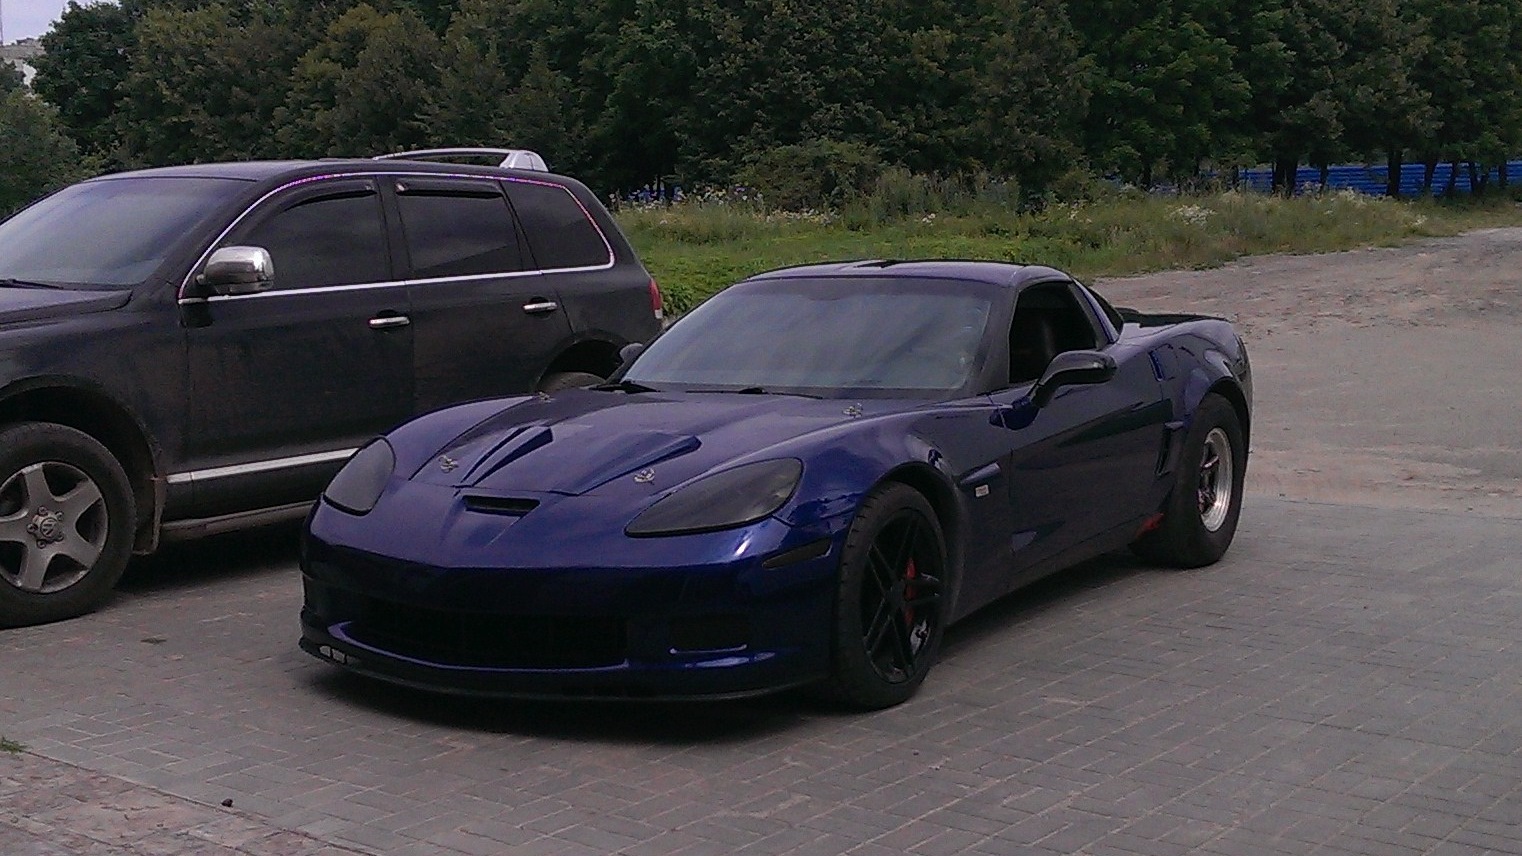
[236, 190, 391, 291]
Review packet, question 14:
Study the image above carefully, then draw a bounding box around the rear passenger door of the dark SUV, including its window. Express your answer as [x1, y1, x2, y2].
[390, 175, 571, 413]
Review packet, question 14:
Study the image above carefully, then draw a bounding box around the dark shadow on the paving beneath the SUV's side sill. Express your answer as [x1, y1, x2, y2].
[117, 521, 301, 594]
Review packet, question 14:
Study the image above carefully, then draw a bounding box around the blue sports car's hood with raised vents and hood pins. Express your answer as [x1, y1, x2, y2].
[412, 390, 912, 497]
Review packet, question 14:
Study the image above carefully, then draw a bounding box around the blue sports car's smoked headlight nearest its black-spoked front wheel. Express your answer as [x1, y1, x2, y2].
[624, 458, 804, 536]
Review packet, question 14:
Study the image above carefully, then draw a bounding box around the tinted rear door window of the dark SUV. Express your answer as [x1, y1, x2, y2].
[397, 183, 524, 279]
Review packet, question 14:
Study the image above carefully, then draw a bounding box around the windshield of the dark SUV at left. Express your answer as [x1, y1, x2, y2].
[0, 175, 248, 288]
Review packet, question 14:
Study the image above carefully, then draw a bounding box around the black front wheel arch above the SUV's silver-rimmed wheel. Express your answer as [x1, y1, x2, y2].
[0, 378, 164, 553]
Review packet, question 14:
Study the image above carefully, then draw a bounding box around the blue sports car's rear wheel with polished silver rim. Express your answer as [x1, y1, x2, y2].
[1131, 393, 1247, 568]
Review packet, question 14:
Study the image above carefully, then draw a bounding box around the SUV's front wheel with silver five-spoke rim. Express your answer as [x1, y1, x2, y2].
[0, 422, 135, 628]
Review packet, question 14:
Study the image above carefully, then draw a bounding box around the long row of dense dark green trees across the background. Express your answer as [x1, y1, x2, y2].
[0, 0, 1522, 210]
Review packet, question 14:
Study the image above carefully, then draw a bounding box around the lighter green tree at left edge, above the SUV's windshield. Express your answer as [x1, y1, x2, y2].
[0, 88, 87, 216]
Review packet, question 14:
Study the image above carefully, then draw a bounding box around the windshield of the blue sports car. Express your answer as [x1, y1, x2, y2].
[624, 277, 991, 398]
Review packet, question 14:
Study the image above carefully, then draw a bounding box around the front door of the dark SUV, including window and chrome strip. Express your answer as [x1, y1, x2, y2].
[170, 178, 412, 516]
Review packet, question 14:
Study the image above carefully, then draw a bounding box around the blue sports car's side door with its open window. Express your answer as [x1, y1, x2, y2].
[961, 280, 1169, 591]
